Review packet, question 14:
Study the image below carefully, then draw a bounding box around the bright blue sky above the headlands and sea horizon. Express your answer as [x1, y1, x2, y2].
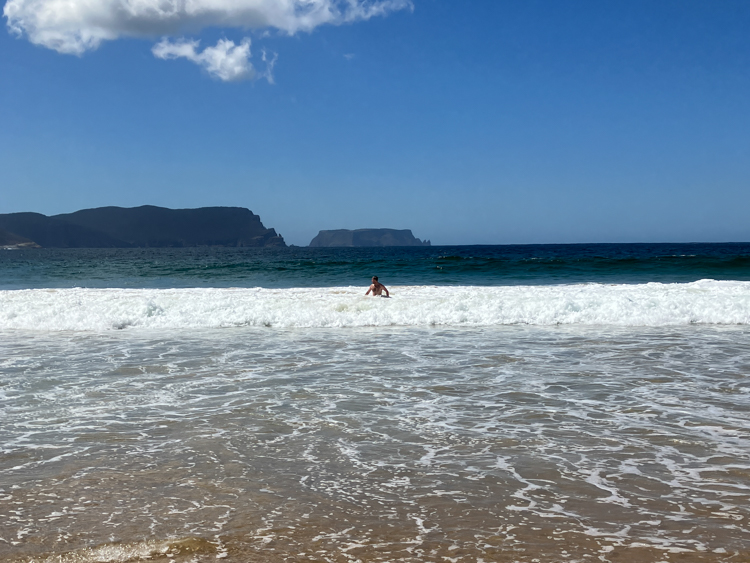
[0, 0, 750, 245]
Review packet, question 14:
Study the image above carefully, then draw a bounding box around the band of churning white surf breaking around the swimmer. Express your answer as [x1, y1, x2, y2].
[0, 280, 750, 331]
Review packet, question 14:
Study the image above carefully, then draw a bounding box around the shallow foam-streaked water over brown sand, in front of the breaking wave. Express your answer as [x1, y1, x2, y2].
[0, 325, 750, 562]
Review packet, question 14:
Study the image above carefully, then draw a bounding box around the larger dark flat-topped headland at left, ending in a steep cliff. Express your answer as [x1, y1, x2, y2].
[0, 205, 286, 248]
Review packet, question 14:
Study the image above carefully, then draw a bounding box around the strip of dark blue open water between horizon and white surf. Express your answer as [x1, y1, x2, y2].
[0, 243, 750, 289]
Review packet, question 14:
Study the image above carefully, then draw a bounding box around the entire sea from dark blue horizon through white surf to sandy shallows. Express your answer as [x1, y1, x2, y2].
[0, 244, 750, 563]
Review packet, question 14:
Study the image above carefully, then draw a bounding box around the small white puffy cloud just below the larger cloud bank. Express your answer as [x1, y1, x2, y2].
[151, 38, 258, 82]
